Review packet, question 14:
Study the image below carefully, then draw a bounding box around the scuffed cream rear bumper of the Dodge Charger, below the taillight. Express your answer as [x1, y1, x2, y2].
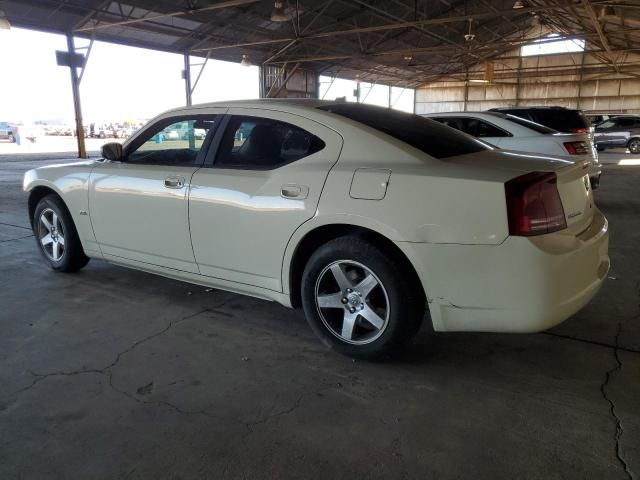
[400, 211, 609, 333]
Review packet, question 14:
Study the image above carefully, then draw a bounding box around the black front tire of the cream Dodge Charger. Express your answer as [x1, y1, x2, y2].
[32, 194, 89, 272]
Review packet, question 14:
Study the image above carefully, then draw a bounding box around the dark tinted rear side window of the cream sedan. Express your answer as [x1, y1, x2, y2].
[215, 116, 325, 170]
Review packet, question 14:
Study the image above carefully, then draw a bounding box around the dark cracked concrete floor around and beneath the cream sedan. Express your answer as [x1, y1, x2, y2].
[0, 156, 640, 480]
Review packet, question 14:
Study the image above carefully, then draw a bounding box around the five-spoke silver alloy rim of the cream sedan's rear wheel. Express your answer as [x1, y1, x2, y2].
[315, 260, 390, 345]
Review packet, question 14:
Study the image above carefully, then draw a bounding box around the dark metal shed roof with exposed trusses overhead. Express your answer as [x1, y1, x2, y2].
[5, 0, 640, 86]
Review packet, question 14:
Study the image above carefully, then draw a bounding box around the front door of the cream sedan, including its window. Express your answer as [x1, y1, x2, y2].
[89, 110, 220, 273]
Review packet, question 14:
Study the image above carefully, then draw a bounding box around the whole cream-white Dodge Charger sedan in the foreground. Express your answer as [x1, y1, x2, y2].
[24, 100, 609, 358]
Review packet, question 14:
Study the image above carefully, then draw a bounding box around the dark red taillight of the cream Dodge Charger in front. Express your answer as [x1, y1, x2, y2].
[504, 172, 567, 236]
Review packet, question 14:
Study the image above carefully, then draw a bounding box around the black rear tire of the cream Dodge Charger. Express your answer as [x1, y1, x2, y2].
[301, 236, 425, 360]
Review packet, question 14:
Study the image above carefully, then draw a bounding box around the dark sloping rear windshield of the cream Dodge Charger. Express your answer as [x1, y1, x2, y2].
[318, 103, 491, 158]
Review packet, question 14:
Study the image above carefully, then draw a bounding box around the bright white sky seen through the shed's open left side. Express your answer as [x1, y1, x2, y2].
[0, 28, 413, 125]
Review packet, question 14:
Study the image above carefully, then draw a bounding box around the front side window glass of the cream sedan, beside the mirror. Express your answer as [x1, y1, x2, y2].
[127, 115, 216, 167]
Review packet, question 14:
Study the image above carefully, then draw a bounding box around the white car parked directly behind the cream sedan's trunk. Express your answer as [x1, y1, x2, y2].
[426, 111, 602, 188]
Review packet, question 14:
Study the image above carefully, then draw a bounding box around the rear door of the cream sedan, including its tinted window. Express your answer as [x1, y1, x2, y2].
[189, 108, 342, 291]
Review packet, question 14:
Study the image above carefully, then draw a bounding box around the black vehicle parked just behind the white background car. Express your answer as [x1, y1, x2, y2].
[490, 107, 592, 134]
